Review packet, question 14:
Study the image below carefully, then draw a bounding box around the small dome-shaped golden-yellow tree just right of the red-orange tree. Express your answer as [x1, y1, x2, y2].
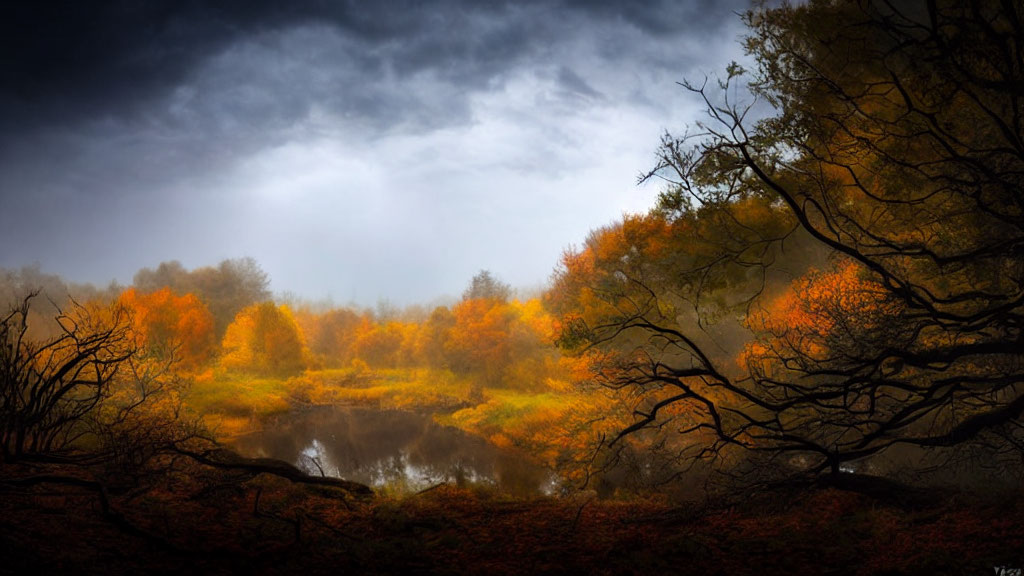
[220, 302, 307, 376]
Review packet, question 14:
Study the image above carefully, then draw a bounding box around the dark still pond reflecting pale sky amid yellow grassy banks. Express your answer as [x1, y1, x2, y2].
[231, 407, 558, 495]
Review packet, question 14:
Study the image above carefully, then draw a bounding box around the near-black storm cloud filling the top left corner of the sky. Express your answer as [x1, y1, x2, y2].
[0, 0, 294, 127]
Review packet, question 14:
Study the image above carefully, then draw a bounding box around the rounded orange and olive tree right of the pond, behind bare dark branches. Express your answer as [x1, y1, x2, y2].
[546, 206, 793, 475]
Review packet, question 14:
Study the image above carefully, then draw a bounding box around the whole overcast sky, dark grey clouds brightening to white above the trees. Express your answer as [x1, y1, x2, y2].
[0, 0, 746, 304]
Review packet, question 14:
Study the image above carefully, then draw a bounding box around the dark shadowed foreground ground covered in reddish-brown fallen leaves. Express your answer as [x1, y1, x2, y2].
[0, 461, 1024, 576]
